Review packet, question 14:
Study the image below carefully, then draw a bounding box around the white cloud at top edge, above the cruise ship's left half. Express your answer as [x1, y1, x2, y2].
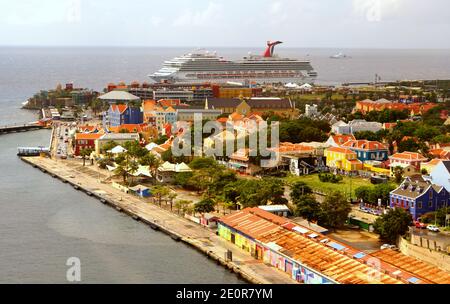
[173, 2, 223, 27]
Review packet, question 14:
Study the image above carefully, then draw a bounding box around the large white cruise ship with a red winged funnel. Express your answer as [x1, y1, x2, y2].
[149, 41, 317, 84]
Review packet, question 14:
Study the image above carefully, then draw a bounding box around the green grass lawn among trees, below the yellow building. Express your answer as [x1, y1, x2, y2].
[286, 174, 374, 199]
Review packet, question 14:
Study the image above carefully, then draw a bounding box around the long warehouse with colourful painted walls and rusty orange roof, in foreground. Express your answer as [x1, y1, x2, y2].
[217, 208, 434, 284]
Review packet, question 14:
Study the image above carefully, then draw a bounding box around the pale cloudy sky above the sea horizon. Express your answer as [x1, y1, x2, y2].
[0, 0, 450, 48]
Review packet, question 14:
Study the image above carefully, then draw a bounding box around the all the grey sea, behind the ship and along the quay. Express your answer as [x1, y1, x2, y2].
[0, 47, 450, 284]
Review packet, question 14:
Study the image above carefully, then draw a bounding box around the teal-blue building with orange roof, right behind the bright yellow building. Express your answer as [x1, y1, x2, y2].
[342, 140, 389, 162]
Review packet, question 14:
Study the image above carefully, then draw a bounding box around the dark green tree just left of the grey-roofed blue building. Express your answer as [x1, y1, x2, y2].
[373, 208, 412, 244]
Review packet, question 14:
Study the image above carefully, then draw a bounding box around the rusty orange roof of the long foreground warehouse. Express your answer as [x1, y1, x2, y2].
[219, 208, 424, 284]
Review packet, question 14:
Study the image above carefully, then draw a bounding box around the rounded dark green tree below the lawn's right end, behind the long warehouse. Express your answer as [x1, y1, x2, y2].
[319, 191, 352, 229]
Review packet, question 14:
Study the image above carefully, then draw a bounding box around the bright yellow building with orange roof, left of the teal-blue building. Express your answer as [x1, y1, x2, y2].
[325, 147, 363, 172]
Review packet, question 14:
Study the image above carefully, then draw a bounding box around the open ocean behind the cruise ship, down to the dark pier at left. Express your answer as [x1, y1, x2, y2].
[0, 47, 450, 125]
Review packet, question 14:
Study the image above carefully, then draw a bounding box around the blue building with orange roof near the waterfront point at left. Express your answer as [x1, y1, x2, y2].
[103, 104, 144, 127]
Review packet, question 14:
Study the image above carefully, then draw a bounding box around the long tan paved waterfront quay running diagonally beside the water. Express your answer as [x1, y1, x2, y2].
[22, 157, 296, 284]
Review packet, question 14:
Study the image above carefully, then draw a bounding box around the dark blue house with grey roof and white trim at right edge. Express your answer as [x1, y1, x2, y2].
[390, 175, 450, 220]
